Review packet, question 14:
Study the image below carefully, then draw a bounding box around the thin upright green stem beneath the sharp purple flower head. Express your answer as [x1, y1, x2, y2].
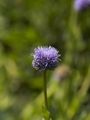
[43, 71, 48, 110]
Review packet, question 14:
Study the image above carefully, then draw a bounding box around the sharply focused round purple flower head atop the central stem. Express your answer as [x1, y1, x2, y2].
[32, 46, 60, 71]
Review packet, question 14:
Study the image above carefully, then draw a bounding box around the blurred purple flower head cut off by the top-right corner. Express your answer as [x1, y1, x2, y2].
[74, 0, 90, 11]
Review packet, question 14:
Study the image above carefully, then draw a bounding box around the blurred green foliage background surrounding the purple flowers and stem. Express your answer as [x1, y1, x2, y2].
[0, 0, 90, 120]
